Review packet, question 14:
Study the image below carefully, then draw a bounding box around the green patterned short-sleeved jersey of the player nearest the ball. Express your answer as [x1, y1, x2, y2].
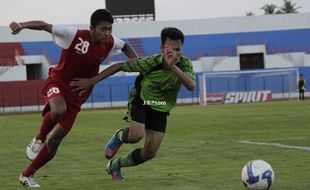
[121, 55, 196, 112]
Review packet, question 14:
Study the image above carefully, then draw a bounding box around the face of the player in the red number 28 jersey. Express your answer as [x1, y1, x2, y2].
[91, 21, 112, 43]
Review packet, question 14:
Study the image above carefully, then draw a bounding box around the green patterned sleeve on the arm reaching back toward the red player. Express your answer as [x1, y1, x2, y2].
[121, 56, 162, 73]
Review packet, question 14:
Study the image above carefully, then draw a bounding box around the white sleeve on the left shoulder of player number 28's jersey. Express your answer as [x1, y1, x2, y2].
[52, 25, 77, 49]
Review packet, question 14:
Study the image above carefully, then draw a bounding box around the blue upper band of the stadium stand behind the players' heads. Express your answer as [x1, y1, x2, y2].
[9, 29, 310, 64]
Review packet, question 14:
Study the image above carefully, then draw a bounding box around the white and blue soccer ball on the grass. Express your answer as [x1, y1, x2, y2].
[241, 160, 274, 190]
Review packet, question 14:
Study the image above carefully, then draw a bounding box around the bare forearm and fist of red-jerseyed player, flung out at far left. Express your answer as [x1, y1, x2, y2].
[9, 21, 52, 35]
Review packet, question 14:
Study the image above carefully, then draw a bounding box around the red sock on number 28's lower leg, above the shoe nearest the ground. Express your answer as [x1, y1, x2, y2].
[23, 144, 55, 177]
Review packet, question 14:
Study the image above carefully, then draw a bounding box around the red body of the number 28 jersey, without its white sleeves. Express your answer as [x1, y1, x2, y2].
[51, 30, 114, 83]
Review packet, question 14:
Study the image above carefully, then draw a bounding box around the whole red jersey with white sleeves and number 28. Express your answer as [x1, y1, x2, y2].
[45, 26, 124, 105]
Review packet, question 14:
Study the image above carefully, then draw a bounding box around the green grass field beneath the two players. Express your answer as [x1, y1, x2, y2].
[0, 101, 310, 190]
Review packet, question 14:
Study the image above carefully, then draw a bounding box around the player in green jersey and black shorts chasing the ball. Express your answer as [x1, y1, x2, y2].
[70, 27, 196, 181]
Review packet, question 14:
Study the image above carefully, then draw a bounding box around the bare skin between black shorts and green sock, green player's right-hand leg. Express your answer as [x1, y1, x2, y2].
[143, 129, 165, 154]
